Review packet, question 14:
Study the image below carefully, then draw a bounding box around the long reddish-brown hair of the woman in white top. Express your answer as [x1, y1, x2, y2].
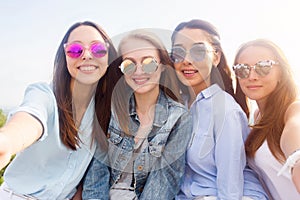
[234, 39, 298, 162]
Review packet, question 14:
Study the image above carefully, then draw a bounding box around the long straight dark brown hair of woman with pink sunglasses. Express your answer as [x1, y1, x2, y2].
[53, 21, 120, 150]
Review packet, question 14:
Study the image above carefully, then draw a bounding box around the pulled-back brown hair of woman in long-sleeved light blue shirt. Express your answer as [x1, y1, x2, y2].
[171, 19, 234, 96]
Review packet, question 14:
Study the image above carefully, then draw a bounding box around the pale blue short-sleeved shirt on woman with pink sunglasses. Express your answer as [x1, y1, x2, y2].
[4, 83, 96, 200]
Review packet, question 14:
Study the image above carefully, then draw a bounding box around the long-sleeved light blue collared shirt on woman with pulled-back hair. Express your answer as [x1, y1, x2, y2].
[176, 84, 265, 200]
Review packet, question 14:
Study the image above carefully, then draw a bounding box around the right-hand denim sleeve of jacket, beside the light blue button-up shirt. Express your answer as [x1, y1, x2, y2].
[139, 112, 192, 200]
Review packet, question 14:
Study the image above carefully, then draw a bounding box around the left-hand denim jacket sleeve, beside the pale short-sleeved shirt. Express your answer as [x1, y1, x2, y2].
[82, 149, 110, 200]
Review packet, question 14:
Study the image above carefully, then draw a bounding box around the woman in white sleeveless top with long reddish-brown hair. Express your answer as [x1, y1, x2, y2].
[233, 39, 300, 200]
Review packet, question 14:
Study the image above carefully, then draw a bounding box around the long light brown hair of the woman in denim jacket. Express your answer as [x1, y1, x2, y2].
[112, 29, 181, 135]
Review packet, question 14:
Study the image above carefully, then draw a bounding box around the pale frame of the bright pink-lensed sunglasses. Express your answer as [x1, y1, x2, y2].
[64, 41, 109, 59]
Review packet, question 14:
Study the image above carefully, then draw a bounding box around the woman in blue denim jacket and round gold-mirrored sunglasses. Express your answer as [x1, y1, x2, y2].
[83, 30, 192, 200]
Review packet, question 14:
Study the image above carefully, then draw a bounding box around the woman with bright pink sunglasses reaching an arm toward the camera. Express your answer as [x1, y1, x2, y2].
[0, 21, 120, 200]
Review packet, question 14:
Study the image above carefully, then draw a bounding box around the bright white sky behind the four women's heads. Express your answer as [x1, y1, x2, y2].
[0, 0, 300, 109]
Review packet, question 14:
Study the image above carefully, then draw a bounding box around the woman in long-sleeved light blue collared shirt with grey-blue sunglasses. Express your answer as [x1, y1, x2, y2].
[171, 19, 266, 200]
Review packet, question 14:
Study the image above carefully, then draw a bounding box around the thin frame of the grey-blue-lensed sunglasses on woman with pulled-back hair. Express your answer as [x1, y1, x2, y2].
[171, 43, 216, 63]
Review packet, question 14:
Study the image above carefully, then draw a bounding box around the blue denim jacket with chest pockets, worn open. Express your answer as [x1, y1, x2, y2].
[84, 91, 192, 200]
